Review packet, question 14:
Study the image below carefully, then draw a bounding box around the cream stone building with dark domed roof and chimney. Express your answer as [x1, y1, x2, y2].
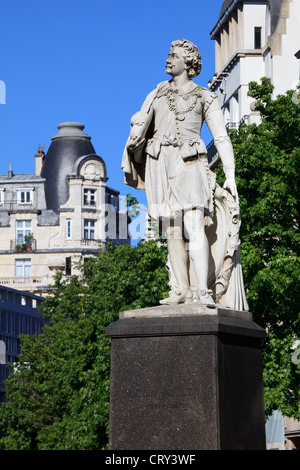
[0, 122, 129, 295]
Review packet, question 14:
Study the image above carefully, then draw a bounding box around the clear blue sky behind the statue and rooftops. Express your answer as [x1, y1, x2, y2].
[0, 0, 223, 209]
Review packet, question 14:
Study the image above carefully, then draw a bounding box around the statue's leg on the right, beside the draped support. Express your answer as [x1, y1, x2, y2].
[184, 208, 215, 306]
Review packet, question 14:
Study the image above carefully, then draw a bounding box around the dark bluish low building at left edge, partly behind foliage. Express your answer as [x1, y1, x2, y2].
[0, 286, 43, 404]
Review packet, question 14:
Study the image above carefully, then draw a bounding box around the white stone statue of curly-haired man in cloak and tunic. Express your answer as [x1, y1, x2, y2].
[122, 39, 247, 310]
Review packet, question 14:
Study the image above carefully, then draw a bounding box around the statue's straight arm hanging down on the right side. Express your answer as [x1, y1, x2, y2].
[204, 92, 237, 197]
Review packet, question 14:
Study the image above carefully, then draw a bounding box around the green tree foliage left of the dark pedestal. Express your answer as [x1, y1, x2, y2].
[0, 241, 168, 450]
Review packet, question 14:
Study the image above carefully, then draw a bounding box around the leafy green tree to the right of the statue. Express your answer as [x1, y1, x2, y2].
[219, 78, 300, 419]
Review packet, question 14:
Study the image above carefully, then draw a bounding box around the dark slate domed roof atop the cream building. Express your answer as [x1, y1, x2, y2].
[41, 122, 95, 212]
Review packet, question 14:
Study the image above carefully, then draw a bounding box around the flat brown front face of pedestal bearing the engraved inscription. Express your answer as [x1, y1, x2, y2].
[111, 336, 216, 449]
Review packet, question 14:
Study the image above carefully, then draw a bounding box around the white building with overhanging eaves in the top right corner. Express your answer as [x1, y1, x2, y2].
[208, 0, 300, 127]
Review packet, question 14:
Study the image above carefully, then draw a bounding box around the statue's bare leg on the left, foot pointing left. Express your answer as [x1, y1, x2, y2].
[160, 226, 193, 304]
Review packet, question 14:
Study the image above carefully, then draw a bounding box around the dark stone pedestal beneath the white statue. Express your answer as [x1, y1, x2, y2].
[106, 305, 265, 450]
